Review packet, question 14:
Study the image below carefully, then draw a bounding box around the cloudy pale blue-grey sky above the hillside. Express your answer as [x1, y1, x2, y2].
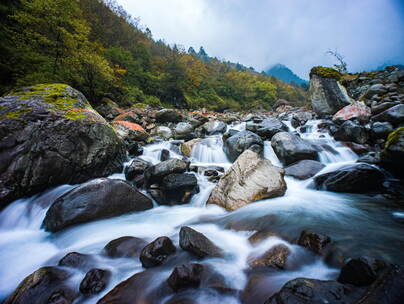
[118, 0, 404, 79]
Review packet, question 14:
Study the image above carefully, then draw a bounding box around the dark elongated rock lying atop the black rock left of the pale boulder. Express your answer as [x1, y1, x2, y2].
[145, 158, 189, 184]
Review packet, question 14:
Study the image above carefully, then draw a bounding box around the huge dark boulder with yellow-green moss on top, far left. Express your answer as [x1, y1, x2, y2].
[0, 84, 126, 208]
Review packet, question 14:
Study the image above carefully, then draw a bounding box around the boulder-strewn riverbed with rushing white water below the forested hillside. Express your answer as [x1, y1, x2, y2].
[0, 67, 404, 304]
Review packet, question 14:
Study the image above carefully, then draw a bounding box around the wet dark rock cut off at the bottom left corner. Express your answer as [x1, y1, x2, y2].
[4, 267, 78, 304]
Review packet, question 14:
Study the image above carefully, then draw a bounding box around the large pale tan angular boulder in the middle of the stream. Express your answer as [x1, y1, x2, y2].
[207, 150, 286, 211]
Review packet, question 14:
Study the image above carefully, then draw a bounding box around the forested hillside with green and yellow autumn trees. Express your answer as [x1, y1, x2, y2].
[0, 0, 306, 110]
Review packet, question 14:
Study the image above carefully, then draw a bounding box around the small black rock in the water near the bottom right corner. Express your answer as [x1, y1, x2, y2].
[338, 258, 376, 286]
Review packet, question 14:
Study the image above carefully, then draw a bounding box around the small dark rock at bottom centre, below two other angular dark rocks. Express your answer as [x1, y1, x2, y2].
[167, 263, 204, 291]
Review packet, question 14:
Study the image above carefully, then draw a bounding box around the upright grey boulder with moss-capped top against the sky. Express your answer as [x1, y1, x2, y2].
[309, 67, 351, 117]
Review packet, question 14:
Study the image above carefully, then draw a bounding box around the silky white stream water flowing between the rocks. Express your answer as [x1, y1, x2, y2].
[0, 121, 404, 304]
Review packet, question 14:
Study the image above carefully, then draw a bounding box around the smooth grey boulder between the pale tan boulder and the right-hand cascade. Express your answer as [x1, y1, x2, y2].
[271, 132, 318, 165]
